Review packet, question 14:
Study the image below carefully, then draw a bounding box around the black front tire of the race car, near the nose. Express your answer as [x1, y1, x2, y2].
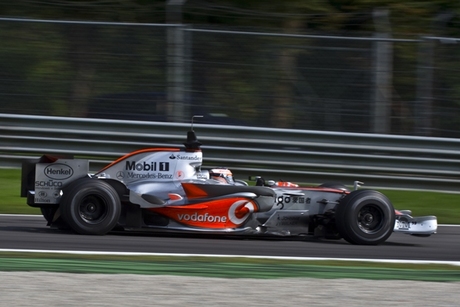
[335, 190, 395, 245]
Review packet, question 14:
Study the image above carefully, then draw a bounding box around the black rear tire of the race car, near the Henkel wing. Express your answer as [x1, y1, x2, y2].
[60, 178, 121, 235]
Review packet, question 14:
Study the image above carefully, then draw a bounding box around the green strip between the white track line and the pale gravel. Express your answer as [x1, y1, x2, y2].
[0, 252, 460, 282]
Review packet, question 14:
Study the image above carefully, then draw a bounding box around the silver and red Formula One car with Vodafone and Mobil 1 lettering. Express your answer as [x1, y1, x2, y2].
[21, 119, 437, 245]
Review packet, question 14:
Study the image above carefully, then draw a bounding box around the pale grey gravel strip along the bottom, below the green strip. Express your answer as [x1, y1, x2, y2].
[0, 272, 460, 307]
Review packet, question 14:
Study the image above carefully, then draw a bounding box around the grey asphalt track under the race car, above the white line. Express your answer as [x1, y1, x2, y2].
[0, 215, 460, 261]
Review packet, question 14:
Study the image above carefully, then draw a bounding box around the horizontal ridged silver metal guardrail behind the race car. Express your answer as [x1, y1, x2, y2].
[0, 114, 460, 192]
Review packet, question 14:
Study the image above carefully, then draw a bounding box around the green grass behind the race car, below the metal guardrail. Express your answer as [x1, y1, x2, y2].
[0, 169, 460, 224]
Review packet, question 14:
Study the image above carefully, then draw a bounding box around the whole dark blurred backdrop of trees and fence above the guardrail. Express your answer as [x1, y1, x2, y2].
[0, 0, 460, 137]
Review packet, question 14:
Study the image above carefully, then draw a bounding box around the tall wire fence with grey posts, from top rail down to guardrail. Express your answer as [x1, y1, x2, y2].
[0, 18, 460, 137]
